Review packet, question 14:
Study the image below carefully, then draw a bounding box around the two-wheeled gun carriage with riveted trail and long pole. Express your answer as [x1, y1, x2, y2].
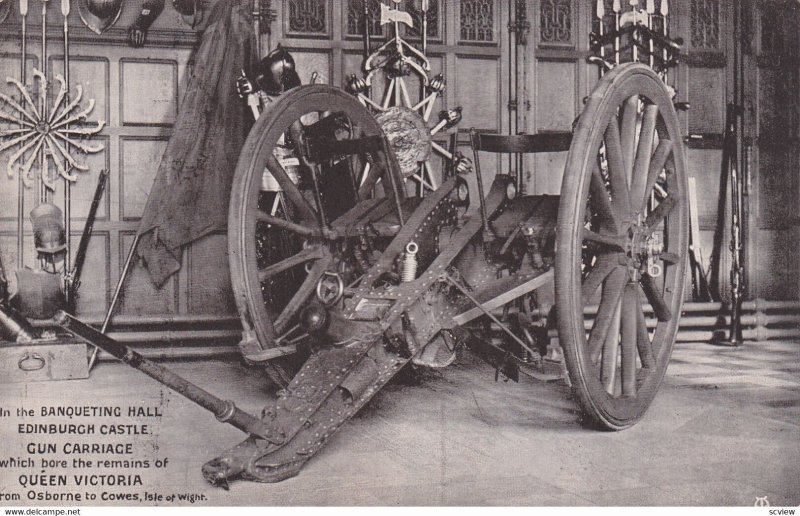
[51, 2, 688, 486]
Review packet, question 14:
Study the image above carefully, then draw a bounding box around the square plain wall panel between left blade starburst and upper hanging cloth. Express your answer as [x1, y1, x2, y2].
[119, 60, 178, 126]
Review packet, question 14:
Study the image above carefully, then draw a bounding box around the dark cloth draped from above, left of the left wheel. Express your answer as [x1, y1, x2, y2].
[138, 0, 257, 286]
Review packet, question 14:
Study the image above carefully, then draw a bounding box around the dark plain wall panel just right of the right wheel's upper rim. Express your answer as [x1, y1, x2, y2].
[688, 67, 727, 134]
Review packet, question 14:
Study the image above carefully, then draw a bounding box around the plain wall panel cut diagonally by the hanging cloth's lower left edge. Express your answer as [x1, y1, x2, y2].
[119, 137, 167, 220]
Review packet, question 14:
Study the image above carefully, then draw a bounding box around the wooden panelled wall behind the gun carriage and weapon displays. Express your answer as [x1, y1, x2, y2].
[0, 0, 800, 322]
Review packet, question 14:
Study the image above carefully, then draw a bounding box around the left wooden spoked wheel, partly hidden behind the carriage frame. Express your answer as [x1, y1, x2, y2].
[228, 85, 402, 385]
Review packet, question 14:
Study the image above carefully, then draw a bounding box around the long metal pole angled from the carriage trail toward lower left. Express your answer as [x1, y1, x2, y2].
[55, 310, 285, 444]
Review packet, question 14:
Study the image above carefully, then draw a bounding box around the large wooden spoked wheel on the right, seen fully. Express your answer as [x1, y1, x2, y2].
[555, 64, 688, 430]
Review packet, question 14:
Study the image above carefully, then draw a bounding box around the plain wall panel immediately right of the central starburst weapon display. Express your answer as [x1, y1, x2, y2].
[448, 56, 500, 131]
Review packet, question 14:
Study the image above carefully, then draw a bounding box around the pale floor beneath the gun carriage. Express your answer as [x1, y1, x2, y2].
[0, 342, 800, 507]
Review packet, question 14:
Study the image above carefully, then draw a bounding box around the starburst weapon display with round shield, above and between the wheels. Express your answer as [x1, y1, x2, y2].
[346, 0, 468, 193]
